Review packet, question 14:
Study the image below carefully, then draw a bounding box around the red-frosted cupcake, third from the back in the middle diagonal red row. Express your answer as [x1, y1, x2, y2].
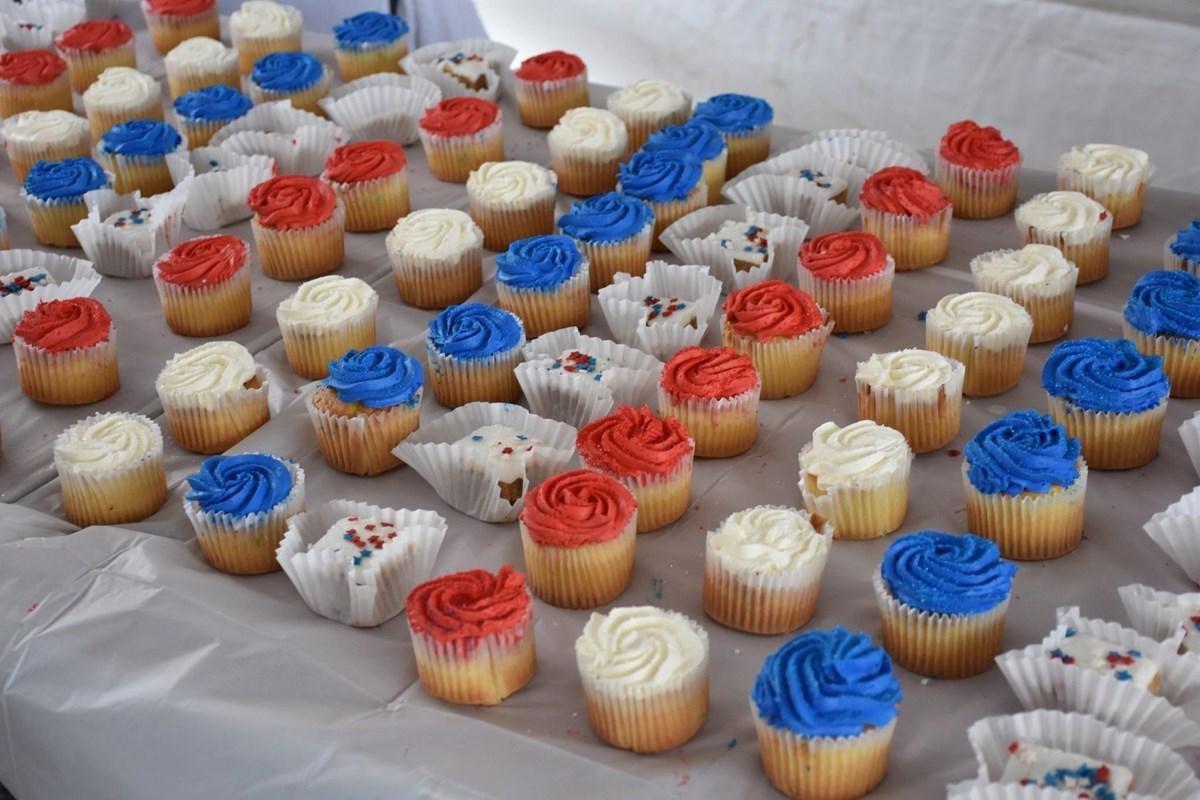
[320, 139, 408, 231]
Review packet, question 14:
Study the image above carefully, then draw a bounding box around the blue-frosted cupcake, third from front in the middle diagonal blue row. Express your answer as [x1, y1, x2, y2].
[425, 302, 526, 408]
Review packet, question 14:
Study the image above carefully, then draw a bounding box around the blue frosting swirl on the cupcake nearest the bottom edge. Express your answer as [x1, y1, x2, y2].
[750, 625, 901, 736]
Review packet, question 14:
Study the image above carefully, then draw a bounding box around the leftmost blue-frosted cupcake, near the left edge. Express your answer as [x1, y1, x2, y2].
[20, 158, 110, 247]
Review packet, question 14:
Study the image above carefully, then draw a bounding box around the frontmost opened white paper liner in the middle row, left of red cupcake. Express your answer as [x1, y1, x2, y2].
[275, 500, 446, 627]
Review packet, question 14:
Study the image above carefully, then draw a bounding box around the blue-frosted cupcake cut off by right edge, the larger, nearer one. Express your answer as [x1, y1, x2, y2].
[1124, 270, 1200, 397]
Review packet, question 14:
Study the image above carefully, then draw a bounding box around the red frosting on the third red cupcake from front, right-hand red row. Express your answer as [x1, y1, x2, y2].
[575, 405, 696, 477]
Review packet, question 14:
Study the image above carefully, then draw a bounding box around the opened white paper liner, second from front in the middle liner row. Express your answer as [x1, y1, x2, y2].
[392, 403, 577, 522]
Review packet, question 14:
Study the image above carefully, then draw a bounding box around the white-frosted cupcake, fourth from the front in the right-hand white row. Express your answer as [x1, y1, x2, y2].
[854, 349, 965, 453]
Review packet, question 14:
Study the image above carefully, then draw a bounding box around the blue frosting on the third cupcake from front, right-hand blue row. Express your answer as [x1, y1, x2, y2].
[964, 411, 1080, 497]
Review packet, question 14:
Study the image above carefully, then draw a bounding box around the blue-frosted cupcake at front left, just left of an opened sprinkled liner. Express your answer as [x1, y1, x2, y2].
[184, 453, 304, 575]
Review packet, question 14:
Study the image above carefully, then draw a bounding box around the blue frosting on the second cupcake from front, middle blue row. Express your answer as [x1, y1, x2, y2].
[324, 345, 425, 408]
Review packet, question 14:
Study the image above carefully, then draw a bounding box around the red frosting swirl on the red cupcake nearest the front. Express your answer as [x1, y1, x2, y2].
[406, 564, 533, 652]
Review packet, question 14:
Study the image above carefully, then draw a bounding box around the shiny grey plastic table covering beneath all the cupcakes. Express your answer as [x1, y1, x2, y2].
[0, 31, 1200, 800]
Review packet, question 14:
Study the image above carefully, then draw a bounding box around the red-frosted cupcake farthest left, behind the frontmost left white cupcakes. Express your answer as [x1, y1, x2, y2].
[12, 297, 121, 405]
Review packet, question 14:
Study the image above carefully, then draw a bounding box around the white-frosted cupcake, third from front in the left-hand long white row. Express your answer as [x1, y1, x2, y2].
[275, 275, 379, 380]
